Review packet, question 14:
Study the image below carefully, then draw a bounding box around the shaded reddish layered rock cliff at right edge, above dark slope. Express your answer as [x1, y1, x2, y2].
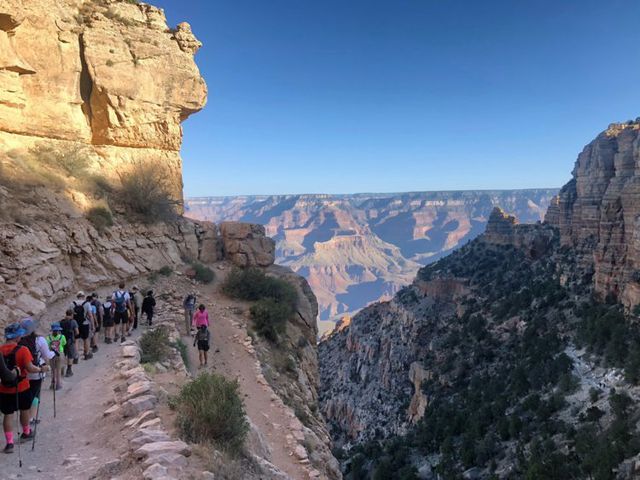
[546, 121, 640, 307]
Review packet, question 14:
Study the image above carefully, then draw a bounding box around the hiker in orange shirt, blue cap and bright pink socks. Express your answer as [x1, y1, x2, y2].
[0, 323, 48, 453]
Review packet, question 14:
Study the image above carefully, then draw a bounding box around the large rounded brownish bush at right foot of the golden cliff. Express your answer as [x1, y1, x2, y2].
[118, 161, 180, 223]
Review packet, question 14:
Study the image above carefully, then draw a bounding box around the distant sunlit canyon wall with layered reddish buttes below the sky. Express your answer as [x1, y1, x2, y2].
[185, 190, 555, 330]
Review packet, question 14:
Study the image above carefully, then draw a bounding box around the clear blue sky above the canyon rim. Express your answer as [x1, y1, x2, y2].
[151, 0, 640, 196]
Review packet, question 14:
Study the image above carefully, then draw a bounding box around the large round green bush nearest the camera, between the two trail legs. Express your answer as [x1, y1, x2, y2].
[175, 373, 249, 455]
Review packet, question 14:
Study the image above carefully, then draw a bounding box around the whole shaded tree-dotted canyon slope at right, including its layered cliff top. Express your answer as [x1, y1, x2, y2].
[319, 121, 640, 479]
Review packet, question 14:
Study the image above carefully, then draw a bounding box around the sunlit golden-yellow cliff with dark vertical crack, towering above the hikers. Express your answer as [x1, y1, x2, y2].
[0, 0, 207, 198]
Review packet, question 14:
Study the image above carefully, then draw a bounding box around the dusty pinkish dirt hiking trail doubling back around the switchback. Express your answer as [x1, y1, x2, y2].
[0, 263, 317, 480]
